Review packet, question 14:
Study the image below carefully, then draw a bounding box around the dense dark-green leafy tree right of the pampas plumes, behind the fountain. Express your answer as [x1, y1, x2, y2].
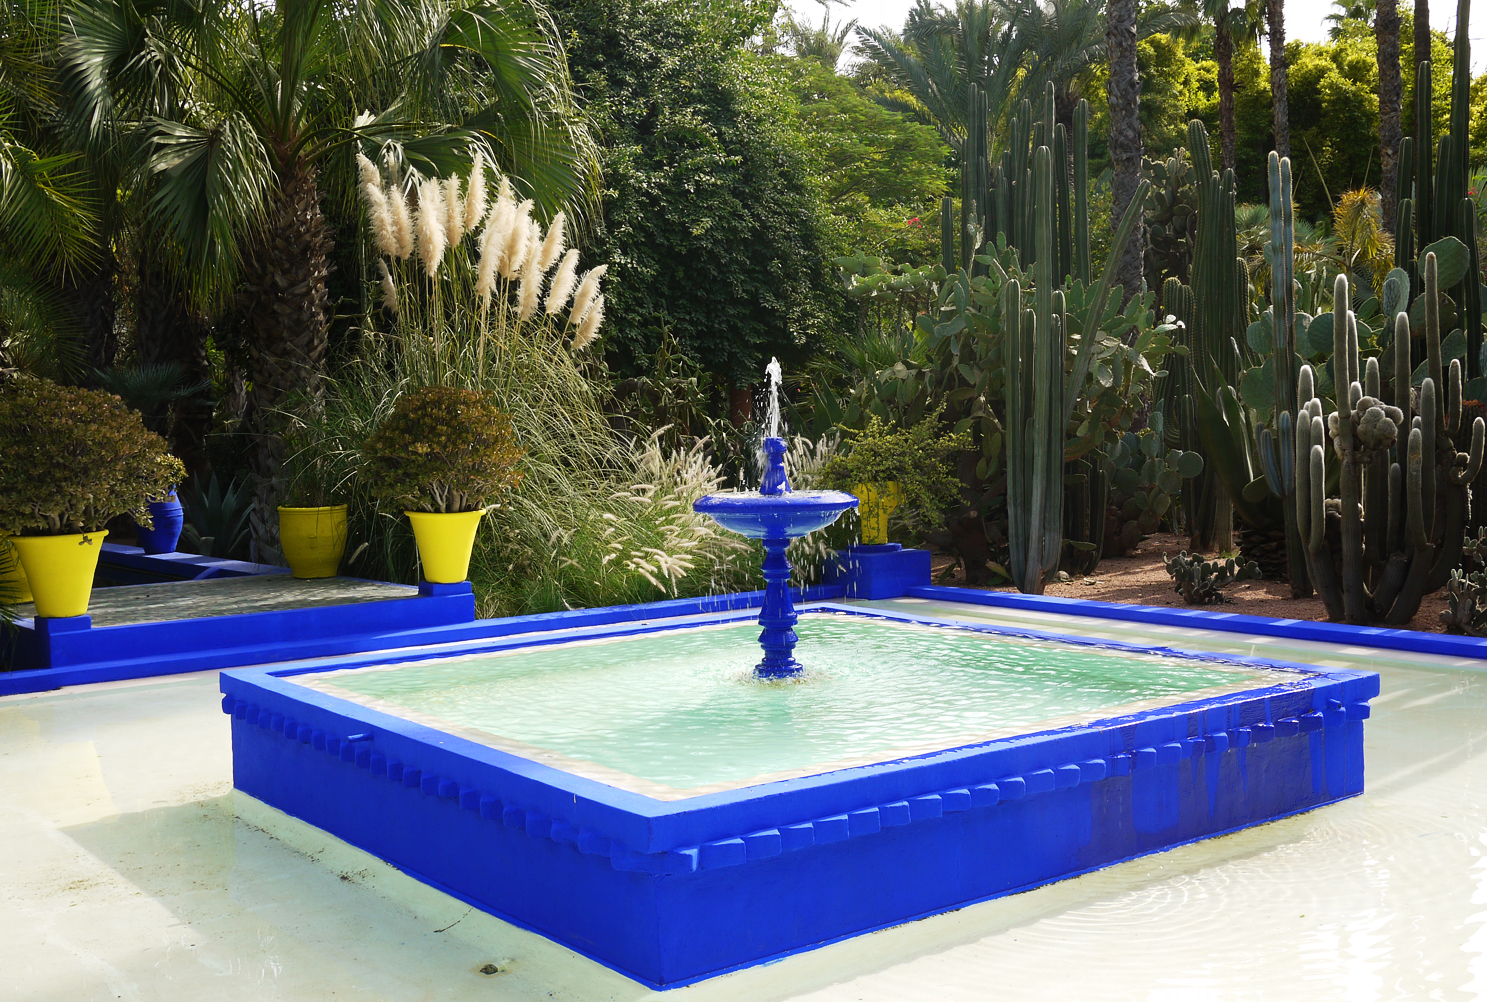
[552, 0, 840, 385]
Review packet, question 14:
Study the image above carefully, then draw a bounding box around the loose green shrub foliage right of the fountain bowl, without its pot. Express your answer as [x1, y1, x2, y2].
[813, 413, 971, 532]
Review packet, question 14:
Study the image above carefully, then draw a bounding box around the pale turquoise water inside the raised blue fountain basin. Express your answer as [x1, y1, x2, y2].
[304, 614, 1276, 791]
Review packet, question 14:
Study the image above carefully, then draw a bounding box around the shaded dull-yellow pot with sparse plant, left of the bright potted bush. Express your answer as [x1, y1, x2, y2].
[278, 422, 346, 578]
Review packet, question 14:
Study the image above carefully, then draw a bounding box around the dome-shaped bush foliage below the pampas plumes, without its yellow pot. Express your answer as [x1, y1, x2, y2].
[361, 387, 522, 511]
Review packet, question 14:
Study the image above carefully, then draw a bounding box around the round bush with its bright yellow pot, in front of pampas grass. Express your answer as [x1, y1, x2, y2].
[363, 387, 522, 584]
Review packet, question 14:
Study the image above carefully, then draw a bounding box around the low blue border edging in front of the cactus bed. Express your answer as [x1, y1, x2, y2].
[903, 584, 1487, 659]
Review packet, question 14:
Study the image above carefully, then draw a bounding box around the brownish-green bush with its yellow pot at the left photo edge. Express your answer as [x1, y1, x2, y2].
[0, 379, 186, 617]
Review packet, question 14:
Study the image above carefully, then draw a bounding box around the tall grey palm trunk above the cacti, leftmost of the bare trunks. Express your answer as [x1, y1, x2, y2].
[1105, 0, 1146, 302]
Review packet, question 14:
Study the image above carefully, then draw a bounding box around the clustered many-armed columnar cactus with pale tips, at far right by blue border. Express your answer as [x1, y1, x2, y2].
[1294, 254, 1487, 626]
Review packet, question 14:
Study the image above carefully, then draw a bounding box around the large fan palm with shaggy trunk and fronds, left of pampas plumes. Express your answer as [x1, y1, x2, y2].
[63, 0, 595, 556]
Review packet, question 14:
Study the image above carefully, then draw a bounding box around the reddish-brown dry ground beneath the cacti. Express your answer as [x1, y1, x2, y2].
[934, 534, 1445, 633]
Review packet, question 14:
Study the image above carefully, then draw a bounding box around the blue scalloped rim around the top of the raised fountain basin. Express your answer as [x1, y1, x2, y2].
[222, 602, 1378, 874]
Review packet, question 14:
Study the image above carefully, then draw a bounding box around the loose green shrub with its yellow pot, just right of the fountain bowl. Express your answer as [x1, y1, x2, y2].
[815, 415, 970, 546]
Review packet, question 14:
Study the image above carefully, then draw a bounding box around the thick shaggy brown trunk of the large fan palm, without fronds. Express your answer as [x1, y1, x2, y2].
[244, 162, 333, 560]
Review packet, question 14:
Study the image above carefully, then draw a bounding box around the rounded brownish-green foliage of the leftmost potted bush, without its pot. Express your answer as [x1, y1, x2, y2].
[0, 379, 186, 535]
